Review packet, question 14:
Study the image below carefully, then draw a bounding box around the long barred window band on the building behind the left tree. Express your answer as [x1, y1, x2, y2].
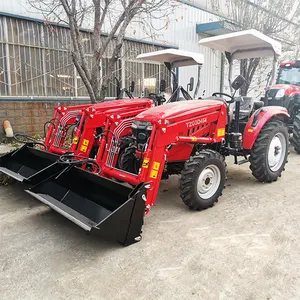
[0, 16, 170, 98]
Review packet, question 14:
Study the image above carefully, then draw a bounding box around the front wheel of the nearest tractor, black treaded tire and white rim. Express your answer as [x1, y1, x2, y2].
[180, 150, 226, 210]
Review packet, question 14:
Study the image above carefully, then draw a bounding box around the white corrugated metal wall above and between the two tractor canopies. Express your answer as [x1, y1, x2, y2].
[128, 4, 221, 95]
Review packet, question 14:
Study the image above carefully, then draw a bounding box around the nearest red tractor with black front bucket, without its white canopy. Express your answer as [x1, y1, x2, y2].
[16, 77, 289, 245]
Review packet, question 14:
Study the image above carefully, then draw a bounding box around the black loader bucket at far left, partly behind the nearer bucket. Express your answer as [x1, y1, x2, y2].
[0, 144, 65, 185]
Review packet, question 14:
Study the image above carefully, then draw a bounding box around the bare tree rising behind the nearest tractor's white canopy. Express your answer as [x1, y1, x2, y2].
[211, 0, 300, 95]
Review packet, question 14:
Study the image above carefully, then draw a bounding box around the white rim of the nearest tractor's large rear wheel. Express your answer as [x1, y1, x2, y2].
[268, 132, 286, 172]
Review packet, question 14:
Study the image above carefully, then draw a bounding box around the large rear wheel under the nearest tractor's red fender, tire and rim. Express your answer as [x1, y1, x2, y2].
[249, 120, 289, 182]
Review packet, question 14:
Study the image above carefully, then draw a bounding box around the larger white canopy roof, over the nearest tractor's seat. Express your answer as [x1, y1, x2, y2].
[199, 29, 281, 59]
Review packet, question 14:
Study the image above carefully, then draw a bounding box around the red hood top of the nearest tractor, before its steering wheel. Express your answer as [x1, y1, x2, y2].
[135, 100, 226, 122]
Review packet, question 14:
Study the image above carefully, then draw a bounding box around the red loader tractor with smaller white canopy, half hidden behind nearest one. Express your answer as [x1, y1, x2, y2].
[0, 49, 204, 184]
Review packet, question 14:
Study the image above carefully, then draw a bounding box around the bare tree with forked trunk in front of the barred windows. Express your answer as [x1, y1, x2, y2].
[28, 0, 176, 103]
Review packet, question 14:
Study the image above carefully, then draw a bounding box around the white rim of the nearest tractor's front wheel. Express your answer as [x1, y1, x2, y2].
[197, 165, 221, 199]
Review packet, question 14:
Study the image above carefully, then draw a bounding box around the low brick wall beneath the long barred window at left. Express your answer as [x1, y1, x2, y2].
[0, 101, 86, 137]
